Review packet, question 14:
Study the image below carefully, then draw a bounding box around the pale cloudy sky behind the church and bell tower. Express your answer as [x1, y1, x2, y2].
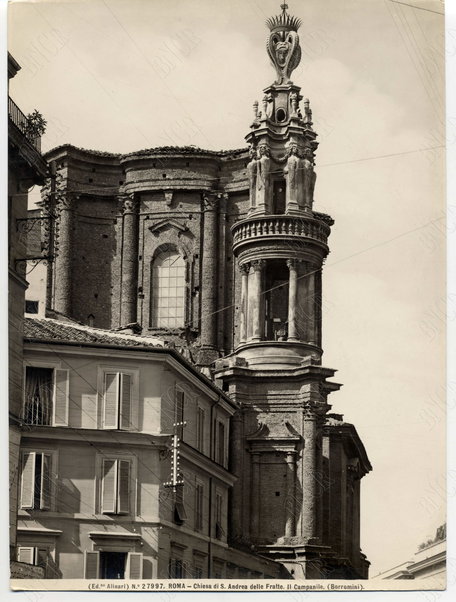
[8, 0, 448, 576]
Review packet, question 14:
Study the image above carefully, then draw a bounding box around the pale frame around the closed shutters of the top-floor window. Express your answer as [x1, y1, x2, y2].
[97, 365, 139, 431]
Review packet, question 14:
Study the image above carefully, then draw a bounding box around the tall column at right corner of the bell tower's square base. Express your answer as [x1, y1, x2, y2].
[302, 404, 318, 541]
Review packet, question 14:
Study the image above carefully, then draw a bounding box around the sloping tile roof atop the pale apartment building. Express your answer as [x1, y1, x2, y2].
[24, 318, 165, 347]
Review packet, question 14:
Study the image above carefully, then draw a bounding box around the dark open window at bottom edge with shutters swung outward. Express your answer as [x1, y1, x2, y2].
[84, 551, 143, 579]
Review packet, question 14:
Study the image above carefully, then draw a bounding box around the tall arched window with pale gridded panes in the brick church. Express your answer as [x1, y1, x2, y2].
[151, 250, 185, 328]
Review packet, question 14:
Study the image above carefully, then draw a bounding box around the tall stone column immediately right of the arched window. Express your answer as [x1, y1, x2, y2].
[200, 195, 218, 349]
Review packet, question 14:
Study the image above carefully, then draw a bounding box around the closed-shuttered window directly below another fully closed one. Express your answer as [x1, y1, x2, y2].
[101, 458, 131, 514]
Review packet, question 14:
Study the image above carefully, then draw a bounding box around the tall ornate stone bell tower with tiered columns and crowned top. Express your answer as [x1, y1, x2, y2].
[215, 4, 370, 578]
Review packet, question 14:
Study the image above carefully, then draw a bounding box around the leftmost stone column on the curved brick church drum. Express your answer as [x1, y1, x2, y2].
[55, 193, 74, 316]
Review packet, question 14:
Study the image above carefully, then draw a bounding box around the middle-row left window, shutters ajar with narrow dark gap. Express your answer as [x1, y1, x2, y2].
[21, 451, 53, 508]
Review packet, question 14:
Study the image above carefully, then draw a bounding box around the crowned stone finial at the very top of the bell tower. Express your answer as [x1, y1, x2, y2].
[266, 3, 301, 84]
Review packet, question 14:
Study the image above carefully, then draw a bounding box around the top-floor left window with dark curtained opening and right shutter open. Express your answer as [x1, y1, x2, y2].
[23, 366, 69, 426]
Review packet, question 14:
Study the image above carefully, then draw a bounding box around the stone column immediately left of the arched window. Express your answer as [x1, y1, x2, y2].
[120, 194, 138, 326]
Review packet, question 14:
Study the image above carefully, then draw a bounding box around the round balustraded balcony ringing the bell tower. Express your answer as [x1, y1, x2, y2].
[231, 215, 330, 251]
